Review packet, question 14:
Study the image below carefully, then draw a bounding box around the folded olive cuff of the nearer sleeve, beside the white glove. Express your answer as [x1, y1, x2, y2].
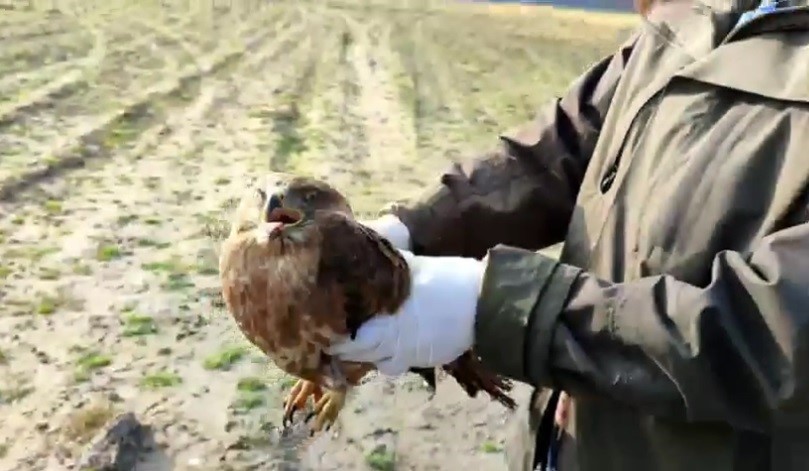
[474, 246, 581, 385]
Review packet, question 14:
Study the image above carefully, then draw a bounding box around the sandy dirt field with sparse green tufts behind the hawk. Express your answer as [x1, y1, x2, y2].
[0, 0, 631, 471]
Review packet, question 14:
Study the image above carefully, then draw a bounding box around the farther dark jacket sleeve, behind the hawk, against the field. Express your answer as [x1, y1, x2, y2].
[390, 38, 634, 258]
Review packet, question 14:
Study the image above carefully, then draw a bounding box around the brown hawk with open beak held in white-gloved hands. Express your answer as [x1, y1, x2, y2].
[219, 177, 515, 434]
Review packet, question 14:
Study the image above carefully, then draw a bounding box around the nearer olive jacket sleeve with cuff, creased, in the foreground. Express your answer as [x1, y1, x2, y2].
[475, 222, 809, 431]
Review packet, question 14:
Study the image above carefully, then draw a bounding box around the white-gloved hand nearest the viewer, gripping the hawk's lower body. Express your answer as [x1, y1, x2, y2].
[327, 250, 485, 376]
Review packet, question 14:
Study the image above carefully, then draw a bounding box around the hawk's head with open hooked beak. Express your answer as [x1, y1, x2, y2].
[258, 177, 352, 243]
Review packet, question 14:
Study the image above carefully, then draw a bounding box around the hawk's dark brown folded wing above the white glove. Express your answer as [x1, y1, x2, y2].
[315, 211, 410, 337]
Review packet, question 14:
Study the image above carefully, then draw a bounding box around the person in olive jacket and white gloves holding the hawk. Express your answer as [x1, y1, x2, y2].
[331, 0, 809, 471]
